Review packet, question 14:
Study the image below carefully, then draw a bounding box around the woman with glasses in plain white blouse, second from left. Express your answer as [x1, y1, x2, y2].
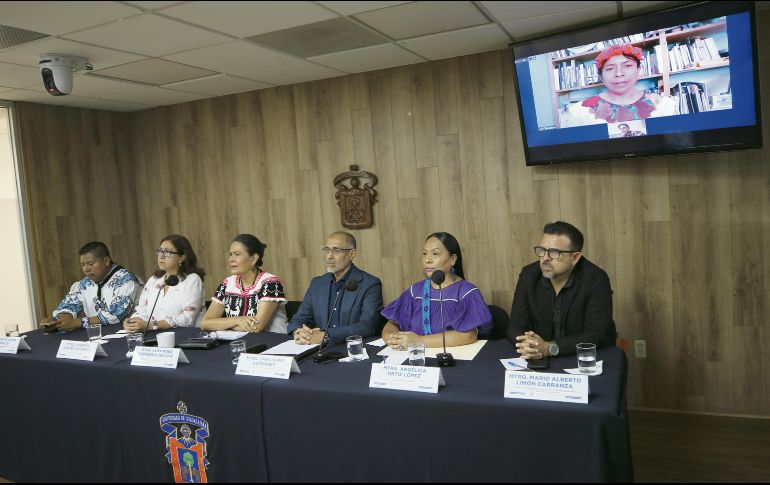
[123, 234, 206, 332]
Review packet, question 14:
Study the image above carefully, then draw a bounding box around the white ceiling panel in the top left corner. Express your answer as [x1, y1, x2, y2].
[0, 2, 141, 35]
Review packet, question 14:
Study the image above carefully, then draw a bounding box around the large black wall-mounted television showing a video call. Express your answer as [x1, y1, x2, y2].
[511, 2, 762, 165]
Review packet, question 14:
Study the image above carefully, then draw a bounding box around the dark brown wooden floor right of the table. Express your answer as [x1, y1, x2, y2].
[629, 411, 770, 482]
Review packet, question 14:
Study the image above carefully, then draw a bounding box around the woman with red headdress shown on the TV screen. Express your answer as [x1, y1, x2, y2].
[561, 44, 675, 128]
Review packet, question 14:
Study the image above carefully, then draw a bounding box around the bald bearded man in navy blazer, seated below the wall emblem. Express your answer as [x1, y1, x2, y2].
[288, 232, 382, 346]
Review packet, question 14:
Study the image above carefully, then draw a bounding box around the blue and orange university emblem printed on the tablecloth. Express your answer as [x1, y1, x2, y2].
[160, 401, 209, 483]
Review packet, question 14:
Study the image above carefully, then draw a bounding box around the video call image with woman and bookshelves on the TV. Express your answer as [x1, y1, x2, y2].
[529, 16, 732, 138]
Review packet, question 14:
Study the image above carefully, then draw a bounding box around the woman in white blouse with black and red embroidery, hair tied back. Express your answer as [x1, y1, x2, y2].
[201, 234, 288, 334]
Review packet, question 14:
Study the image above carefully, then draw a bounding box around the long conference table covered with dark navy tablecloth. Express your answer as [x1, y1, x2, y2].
[0, 327, 633, 482]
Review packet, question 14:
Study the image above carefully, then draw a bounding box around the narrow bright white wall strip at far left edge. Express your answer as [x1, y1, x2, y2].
[0, 106, 35, 335]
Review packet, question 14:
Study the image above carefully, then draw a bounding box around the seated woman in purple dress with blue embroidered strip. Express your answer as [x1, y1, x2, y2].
[382, 232, 492, 348]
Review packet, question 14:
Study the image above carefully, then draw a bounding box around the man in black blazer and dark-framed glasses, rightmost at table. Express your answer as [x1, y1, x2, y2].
[508, 221, 615, 359]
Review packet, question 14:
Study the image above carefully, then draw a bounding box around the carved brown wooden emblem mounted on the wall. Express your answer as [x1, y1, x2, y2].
[334, 165, 377, 229]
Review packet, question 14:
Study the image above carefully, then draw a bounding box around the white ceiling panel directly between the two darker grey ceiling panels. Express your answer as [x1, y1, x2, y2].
[163, 40, 289, 74]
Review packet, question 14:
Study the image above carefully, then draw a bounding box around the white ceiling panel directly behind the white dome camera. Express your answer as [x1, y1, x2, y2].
[0, 37, 142, 69]
